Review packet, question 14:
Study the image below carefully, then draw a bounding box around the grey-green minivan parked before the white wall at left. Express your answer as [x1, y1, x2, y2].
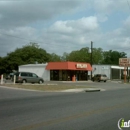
[15, 72, 44, 84]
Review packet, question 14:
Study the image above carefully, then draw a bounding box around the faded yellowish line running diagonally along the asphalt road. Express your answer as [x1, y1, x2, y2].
[13, 101, 130, 130]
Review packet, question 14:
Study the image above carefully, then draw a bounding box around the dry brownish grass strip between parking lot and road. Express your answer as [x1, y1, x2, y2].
[0, 84, 90, 91]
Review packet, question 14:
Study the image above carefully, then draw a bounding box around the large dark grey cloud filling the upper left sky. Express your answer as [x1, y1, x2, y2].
[0, 0, 84, 28]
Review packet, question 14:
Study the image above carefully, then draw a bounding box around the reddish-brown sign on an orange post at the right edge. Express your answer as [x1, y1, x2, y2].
[119, 58, 130, 82]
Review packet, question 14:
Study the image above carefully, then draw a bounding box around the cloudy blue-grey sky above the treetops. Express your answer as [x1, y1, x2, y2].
[0, 0, 130, 57]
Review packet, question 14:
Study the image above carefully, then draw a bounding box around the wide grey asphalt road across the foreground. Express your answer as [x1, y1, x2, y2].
[0, 82, 130, 130]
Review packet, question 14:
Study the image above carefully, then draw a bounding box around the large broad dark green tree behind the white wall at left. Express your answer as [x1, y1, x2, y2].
[5, 43, 51, 70]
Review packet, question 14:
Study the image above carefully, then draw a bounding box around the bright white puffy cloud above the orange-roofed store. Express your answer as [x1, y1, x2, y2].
[49, 16, 98, 34]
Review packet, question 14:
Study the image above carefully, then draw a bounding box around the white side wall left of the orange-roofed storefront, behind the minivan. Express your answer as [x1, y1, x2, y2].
[19, 64, 50, 81]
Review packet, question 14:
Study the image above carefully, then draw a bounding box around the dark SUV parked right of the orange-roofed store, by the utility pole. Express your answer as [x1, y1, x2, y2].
[92, 74, 108, 82]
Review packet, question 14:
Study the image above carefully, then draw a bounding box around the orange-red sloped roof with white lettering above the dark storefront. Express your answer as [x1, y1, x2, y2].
[46, 61, 92, 71]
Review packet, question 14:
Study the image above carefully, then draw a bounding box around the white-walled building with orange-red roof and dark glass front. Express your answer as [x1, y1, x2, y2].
[19, 61, 92, 81]
